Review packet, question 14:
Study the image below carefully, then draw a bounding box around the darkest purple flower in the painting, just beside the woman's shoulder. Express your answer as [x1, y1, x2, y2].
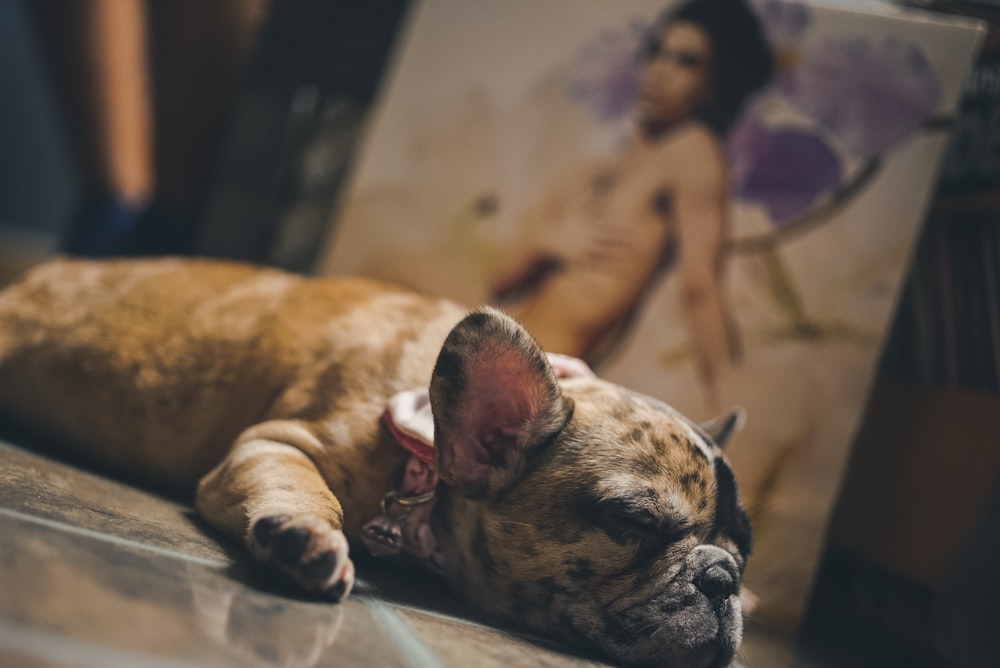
[727, 115, 842, 229]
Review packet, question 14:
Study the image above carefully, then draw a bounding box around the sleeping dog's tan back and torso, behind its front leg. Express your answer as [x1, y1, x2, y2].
[0, 259, 462, 488]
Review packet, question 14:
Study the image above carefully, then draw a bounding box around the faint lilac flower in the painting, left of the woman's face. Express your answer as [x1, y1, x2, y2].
[569, 19, 648, 121]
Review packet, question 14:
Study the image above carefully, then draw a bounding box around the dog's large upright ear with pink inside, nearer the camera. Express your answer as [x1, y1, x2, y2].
[430, 307, 571, 495]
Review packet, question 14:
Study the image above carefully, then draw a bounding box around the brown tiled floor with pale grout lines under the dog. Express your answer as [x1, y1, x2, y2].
[0, 428, 802, 668]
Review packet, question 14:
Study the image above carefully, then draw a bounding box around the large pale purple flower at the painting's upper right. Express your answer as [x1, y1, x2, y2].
[779, 37, 941, 158]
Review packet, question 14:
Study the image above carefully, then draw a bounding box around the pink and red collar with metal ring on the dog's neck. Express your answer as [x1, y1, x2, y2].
[361, 390, 444, 573]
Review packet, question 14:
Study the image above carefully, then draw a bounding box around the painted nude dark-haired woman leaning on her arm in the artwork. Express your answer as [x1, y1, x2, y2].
[491, 0, 772, 403]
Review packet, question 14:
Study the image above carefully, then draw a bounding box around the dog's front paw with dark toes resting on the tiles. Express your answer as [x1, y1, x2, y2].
[250, 514, 354, 601]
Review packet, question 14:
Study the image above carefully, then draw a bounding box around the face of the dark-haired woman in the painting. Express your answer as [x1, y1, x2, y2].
[635, 21, 712, 127]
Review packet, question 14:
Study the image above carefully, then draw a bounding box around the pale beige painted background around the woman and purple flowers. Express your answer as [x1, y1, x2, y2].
[319, 0, 971, 630]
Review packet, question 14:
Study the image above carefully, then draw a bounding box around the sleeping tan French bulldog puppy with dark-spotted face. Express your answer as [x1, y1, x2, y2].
[0, 260, 750, 666]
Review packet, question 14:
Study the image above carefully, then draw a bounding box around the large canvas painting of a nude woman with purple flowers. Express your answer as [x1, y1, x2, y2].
[318, 0, 981, 630]
